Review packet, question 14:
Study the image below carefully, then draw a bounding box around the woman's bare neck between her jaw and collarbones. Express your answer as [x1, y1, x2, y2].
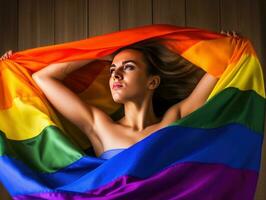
[120, 97, 160, 131]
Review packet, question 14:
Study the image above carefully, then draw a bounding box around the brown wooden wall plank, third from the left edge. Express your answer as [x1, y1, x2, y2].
[55, 0, 88, 43]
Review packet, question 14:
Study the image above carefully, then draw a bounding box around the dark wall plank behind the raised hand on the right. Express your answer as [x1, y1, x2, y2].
[221, 0, 266, 200]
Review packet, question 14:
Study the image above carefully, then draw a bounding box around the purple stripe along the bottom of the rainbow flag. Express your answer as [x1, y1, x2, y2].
[13, 162, 258, 200]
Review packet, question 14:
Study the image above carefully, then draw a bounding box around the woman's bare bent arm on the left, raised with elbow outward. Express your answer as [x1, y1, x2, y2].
[32, 56, 112, 139]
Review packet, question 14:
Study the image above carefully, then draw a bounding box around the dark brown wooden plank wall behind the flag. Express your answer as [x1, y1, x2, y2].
[0, 0, 266, 200]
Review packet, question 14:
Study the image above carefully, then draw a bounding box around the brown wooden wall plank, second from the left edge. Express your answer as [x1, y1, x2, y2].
[18, 0, 54, 50]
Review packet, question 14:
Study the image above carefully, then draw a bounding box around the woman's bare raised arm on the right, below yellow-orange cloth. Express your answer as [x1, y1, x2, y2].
[178, 73, 219, 118]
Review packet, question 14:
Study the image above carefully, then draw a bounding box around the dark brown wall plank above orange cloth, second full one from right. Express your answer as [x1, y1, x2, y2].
[186, 0, 220, 31]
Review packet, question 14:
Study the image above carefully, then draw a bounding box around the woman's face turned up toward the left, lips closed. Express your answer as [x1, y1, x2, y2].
[109, 49, 154, 103]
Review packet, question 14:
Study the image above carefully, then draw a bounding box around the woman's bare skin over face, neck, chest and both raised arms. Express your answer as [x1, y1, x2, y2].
[0, 49, 218, 156]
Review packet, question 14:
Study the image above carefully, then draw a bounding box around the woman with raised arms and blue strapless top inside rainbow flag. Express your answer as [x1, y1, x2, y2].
[2, 39, 218, 159]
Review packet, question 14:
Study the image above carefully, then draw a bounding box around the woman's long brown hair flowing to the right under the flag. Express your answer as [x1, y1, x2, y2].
[112, 38, 205, 116]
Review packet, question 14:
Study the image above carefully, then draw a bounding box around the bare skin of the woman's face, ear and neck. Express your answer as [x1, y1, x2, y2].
[109, 49, 160, 131]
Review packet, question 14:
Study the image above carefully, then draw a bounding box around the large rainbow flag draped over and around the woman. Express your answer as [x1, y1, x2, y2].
[0, 24, 265, 200]
